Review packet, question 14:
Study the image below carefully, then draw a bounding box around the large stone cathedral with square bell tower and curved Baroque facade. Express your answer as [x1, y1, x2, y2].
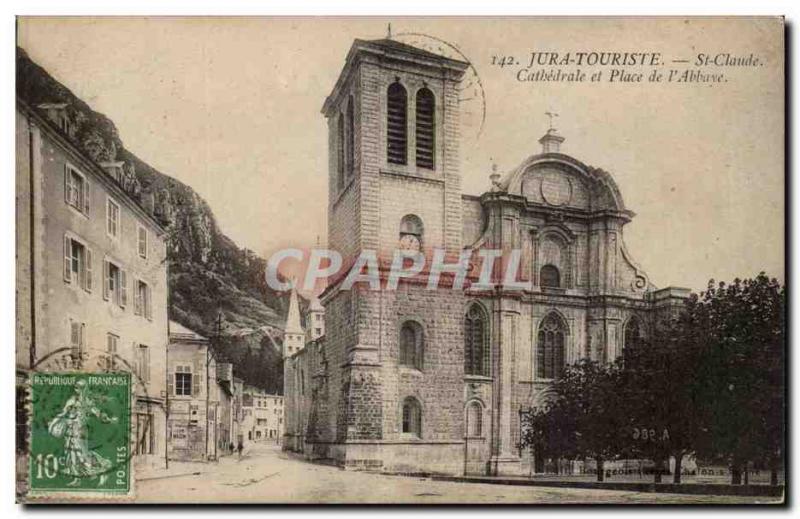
[283, 35, 688, 475]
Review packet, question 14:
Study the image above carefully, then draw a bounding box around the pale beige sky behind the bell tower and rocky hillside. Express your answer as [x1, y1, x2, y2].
[18, 17, 785, 290]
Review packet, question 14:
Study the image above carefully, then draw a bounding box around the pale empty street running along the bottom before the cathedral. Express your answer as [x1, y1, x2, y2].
[136, 443, 772, 504]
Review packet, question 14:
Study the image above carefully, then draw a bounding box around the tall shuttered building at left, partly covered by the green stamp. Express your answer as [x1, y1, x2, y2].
[16, 99, 167, 472]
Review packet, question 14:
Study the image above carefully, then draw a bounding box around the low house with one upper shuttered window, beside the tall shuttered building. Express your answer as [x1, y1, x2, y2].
[167, 321, 235, 461]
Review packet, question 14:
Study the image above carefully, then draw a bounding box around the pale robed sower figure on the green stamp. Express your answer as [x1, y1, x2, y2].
[47, 380, 117, 486]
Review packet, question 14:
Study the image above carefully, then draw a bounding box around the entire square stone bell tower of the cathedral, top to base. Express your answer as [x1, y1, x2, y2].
[320, 38, 469, 470]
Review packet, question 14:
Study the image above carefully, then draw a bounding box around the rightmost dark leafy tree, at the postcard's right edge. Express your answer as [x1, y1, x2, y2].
[688, 272, 785, 484]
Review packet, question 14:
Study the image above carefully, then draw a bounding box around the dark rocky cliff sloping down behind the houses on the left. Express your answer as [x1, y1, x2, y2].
[16, 48, 290, 392]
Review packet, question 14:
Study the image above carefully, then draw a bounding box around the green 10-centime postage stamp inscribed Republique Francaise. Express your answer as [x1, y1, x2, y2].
[29, 373, 131, 494]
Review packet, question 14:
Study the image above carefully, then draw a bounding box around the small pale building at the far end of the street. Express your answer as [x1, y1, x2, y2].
[241, 386, 284, 445]
